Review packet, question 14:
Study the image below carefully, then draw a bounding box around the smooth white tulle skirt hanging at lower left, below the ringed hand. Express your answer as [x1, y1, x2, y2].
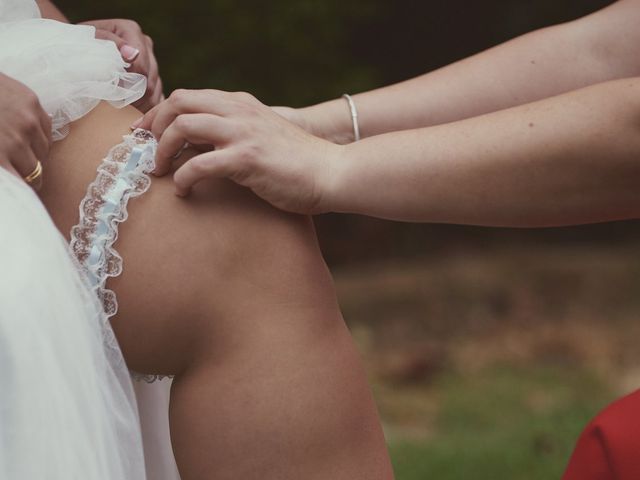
[0, 169, 145, 480]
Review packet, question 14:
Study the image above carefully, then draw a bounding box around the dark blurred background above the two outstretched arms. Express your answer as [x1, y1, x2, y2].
[59, 0, 611, 105]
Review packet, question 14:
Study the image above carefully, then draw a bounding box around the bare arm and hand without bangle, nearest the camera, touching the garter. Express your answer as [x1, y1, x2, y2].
[143, 79, 640, 227]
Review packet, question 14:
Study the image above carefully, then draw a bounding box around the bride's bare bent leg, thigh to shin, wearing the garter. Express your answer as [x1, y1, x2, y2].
[41, 102, 392, 480]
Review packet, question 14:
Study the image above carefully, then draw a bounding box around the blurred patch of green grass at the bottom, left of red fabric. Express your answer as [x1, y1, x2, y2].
[389, 365, 613, 480]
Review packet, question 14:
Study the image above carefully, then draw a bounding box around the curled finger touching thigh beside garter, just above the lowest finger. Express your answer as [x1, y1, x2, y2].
[153, 113, 232, 176]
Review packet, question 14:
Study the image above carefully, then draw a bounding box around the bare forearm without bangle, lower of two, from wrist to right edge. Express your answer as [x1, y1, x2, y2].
[326, 79, 640, 227]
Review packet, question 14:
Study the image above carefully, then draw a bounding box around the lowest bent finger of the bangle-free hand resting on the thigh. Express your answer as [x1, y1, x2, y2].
[173, 150, 241, 197]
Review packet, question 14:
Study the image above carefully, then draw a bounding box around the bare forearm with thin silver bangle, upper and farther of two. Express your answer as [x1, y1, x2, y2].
[303, 0, 640, 143]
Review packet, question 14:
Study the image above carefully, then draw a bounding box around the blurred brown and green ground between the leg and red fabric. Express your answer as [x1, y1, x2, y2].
[335, 245, 640, 480]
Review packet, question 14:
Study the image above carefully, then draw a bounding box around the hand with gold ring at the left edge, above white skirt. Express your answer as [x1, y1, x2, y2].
[0, 73, 51, 189]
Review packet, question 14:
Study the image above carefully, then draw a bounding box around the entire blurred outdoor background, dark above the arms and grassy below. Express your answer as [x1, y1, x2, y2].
[59, 0, 640, 480]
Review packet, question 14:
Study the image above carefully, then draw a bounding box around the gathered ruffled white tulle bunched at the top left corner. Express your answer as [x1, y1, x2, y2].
[0, 0, 146, 140]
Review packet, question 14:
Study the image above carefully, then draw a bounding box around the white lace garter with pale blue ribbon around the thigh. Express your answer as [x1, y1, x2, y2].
[70, 129, 164, 382]
